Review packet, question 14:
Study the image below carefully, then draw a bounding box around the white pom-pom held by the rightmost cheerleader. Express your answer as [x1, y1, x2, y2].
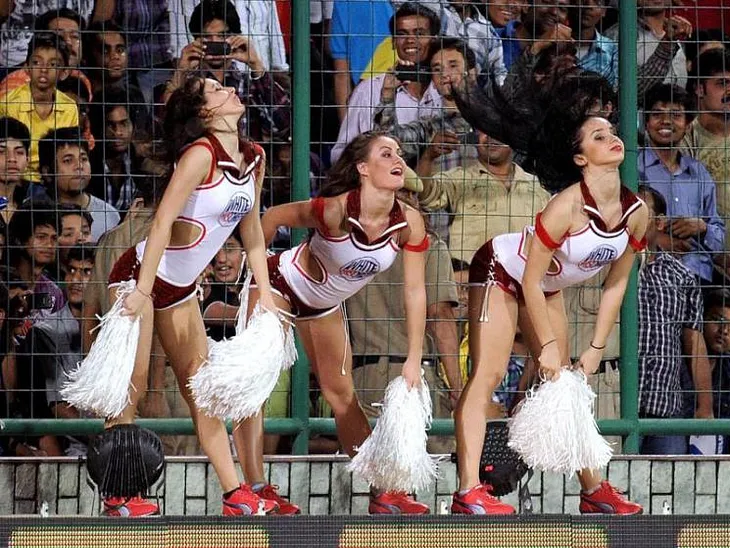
[509, 369, 612, 475]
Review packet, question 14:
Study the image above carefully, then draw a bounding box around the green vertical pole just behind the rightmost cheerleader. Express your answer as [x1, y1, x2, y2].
[619, 0, 639, 454]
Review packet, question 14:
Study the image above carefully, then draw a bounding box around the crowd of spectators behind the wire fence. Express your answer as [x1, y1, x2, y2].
[0, 0, 730, 462]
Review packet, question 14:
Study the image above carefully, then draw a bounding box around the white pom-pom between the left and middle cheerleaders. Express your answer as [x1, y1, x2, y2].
[189, 305, 297, 421]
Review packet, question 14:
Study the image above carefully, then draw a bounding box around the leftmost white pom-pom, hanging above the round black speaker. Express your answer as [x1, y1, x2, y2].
[61, 280, 139, 419]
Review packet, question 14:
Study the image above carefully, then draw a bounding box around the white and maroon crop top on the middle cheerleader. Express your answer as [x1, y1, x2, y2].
[279, 189, 428, 309]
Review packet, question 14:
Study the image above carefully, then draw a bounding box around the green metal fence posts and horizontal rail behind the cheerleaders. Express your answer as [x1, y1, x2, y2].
[0, 0, 730, 455]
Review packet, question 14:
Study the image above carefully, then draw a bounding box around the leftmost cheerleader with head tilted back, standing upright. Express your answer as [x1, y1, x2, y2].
[104, 78, 277, 516]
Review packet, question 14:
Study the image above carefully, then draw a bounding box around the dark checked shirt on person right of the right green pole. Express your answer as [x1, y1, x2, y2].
[639, 252, 703, 417]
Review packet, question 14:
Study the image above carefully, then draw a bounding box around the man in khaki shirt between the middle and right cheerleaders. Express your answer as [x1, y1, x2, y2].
[419, 132, 550, 263]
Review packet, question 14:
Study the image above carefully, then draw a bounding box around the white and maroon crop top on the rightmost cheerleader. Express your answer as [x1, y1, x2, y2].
[492, 182, 646, 292]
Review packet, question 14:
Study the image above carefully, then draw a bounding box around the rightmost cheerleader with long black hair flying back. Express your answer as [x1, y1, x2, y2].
[452, 71, 648, 514]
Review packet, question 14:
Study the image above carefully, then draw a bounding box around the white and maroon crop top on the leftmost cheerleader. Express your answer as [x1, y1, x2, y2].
[137, 135, 263, 287]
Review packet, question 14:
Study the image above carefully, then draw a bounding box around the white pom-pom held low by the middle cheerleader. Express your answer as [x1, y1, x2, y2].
[348, 376, 438, 492]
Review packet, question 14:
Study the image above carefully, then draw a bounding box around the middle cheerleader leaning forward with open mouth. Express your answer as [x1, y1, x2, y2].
[233, 132, 429, 514]
